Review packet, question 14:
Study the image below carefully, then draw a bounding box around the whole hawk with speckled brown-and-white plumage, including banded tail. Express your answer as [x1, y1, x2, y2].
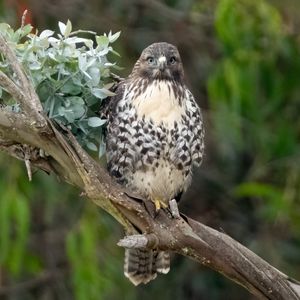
[106, 43, 204, 285]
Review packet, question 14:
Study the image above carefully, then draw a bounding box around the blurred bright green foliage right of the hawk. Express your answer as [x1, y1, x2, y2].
[208, 0, 300, 228]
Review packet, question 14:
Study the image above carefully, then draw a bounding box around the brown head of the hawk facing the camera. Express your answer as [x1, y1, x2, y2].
[132, 43, 184, 82]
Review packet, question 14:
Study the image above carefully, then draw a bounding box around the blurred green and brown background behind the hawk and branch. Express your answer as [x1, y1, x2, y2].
[0, 0, 300, 300]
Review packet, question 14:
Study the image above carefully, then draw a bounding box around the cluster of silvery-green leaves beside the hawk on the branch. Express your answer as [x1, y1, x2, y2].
[0, 21, 120, 156]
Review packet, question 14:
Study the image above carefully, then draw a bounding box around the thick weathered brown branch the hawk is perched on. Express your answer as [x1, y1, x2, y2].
[0, 31, 300, 299]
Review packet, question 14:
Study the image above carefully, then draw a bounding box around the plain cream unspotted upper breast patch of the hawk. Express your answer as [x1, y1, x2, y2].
[131, 81, 185, 127]
